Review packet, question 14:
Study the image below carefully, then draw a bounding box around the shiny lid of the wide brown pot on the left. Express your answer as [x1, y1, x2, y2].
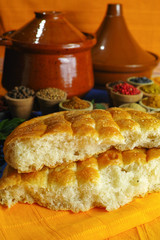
[7, 11, 95, 49]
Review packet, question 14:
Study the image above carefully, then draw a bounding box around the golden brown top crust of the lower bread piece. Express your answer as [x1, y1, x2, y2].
[0, 148, 160, 189]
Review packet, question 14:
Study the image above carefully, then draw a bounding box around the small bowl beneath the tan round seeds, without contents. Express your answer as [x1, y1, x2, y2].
[36, 93, 67, 115]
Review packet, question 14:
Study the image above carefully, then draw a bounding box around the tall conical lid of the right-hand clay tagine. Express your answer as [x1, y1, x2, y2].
[92, 4, 159, 72]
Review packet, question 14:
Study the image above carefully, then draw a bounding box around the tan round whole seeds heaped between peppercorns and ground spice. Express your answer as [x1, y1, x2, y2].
[37, 88, 66, 100]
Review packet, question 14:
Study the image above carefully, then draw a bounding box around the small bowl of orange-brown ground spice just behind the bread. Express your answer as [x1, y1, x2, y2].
[59, 96, 93, 110]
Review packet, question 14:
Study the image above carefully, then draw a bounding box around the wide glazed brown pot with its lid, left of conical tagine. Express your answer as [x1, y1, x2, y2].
[0, 12, 96, 97]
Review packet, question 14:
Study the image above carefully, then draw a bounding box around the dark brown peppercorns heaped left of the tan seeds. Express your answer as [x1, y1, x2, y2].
[7, 86, 35, 99]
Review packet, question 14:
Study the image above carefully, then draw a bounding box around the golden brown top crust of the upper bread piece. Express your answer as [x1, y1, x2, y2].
[4, 108, 160, 151]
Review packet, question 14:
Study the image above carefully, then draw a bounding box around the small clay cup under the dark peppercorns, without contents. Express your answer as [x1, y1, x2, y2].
[5, 94, 34, 119]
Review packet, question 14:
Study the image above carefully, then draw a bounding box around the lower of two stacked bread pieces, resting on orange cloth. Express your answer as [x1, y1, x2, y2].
[0, 149, 160, 212]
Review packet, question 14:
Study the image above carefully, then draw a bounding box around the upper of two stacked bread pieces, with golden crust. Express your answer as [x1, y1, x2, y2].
[4, 108, 160, 172]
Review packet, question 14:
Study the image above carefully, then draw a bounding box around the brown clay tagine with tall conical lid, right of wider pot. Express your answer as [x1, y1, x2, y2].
[92, 4, 159, 87]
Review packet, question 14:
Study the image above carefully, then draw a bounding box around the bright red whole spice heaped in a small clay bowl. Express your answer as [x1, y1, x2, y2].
[113, 83, 140, 95]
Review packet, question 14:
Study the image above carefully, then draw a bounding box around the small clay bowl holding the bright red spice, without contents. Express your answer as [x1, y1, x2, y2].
[110, 90, 143, 107]
